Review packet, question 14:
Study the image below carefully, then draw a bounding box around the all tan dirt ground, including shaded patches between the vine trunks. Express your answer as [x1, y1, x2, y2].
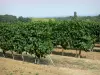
[0, 49, 100, 75]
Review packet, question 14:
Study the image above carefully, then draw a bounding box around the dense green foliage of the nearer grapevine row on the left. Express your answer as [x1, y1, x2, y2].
[0, 22, 53, 63]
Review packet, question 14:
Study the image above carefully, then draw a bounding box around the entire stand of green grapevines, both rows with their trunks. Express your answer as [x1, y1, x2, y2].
[0, 20, 100, 64]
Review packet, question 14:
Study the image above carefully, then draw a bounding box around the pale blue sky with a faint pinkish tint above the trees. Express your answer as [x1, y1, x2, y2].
[0, 0, 100, 17]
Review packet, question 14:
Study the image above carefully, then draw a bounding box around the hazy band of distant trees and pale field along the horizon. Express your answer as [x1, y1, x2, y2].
[0, 12, 100, 23]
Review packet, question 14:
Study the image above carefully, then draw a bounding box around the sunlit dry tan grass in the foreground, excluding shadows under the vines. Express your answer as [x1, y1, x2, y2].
[0, 55, 100, 75]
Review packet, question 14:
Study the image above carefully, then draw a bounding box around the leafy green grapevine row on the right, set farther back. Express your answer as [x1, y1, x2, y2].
[52, 20, 100, 57]
